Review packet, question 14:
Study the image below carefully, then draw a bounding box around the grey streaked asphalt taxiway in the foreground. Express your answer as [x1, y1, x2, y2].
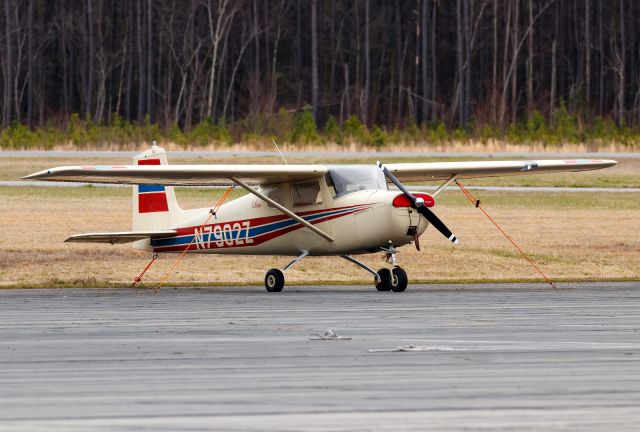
[0, 282, 640, 431]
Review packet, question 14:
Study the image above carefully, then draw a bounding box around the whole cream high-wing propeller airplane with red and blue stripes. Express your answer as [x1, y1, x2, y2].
[24, 145, 616, 292]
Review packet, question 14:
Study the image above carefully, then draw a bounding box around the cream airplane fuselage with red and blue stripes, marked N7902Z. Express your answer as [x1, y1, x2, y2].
[142, 190, 427, 256]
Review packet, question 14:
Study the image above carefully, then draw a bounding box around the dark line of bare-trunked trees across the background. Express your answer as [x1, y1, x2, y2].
[0, 0, 640, 141]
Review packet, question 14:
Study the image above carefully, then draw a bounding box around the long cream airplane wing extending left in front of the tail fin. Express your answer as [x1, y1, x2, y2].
[23, 165, 328, 186]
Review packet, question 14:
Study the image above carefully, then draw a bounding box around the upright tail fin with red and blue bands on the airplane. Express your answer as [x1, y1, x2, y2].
[132, 142, 182, 231]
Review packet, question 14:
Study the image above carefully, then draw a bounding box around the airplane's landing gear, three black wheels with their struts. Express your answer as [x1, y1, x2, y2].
[264, 242, 408, 292]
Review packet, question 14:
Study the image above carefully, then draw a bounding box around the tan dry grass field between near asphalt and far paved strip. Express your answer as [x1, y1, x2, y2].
[0, 181, 640, 287]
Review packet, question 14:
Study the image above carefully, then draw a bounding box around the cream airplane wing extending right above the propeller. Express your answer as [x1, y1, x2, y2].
[385, 159, 617, 182]
